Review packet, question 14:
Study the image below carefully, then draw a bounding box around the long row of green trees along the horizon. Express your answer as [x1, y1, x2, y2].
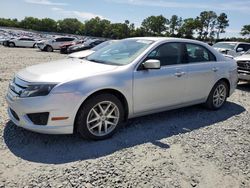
[0, 11, 250, 41]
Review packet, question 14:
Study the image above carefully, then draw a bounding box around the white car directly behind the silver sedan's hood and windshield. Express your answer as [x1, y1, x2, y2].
[68, 40, 117, 58]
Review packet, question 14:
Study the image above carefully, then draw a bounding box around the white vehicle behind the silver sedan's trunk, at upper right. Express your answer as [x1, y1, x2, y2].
[213, 42, 250, 57]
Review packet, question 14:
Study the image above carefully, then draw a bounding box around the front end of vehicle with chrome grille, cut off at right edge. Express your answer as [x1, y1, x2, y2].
[234, 50, 250, 82]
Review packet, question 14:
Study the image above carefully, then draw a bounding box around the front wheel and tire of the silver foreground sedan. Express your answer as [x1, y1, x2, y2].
[75, 94, 124, 140]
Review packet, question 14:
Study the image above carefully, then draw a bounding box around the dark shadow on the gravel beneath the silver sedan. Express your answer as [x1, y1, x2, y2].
[3, 102, 245, 164]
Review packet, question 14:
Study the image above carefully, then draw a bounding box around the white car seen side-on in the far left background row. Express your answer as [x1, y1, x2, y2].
[8, 37, 38, 48]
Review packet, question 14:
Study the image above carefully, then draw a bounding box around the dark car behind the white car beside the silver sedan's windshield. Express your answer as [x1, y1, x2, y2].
[68, 39, 106, 53]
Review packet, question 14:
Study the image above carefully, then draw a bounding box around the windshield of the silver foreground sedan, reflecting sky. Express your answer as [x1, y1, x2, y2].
[86, 39, 153, 65]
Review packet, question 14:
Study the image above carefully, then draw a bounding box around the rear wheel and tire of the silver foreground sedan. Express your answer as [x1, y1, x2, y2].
[205, 80, 229, 110]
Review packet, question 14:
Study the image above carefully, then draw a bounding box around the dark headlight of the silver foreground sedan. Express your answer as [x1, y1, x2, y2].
[20, 84, 56, 97]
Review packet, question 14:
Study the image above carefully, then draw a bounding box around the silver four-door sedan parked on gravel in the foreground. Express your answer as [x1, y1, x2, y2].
[6, 37, 238, 140]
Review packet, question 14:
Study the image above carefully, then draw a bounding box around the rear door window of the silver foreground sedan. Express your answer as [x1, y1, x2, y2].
[186, 44, 216, 63]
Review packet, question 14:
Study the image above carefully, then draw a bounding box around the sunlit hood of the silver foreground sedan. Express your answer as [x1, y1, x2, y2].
[16, 58, 118, 83]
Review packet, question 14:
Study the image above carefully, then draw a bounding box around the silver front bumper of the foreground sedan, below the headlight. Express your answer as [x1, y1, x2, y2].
[6, 89, 84, 134]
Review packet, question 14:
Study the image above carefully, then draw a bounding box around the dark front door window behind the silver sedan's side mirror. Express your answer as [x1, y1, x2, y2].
[147, 43, 183, 66]
